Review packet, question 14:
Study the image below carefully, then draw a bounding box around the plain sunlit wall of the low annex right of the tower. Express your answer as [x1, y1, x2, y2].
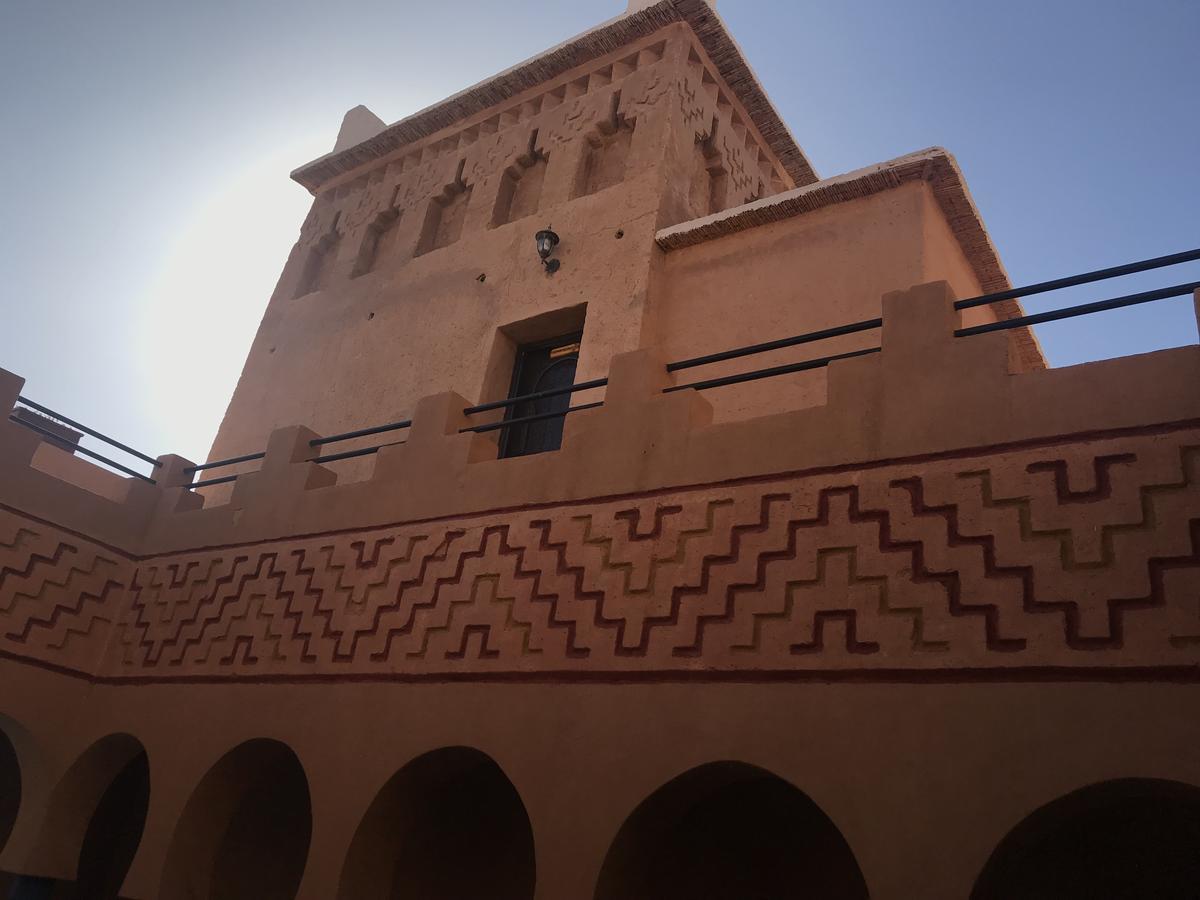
[652, 181, 995, 421]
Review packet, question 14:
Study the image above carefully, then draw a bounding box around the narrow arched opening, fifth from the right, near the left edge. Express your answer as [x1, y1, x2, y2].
[20, 734, 150, 900]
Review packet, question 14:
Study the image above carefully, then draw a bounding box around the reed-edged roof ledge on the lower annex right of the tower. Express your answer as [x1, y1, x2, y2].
[655, 146, 1045, 368]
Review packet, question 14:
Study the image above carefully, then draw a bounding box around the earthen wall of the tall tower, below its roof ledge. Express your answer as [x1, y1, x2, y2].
[211, 24, 791, 482]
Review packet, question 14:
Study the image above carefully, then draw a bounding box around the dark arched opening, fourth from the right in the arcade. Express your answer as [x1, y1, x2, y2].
[158, 739, 312, 900]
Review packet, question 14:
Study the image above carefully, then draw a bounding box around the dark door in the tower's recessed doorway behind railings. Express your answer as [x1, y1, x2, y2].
[500, 334, 582, 457]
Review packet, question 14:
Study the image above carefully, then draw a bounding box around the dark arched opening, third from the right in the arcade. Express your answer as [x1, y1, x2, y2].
[337, 746, 535, 900]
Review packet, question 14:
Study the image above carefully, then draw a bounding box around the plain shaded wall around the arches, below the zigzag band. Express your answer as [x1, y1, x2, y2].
[0, 661, 1200, 900]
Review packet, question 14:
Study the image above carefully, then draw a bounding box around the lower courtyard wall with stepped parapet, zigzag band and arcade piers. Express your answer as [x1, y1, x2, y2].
[0, 282, 1200, 900]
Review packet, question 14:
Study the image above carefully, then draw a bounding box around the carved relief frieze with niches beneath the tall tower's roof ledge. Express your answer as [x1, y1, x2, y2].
[277, 41, 782, 289]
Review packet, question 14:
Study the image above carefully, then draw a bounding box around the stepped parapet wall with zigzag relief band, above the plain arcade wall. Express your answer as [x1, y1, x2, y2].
[0, 283, 1200, 683]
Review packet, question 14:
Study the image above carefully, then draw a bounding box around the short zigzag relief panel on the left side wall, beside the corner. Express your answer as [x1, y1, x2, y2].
[0, 510, 132, 668]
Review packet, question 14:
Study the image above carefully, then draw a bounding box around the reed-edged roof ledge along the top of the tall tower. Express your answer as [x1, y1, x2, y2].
[292, 0, 817, 192]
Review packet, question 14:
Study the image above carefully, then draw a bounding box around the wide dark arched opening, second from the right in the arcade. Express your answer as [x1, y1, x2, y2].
[595, 762, 868, 900]
